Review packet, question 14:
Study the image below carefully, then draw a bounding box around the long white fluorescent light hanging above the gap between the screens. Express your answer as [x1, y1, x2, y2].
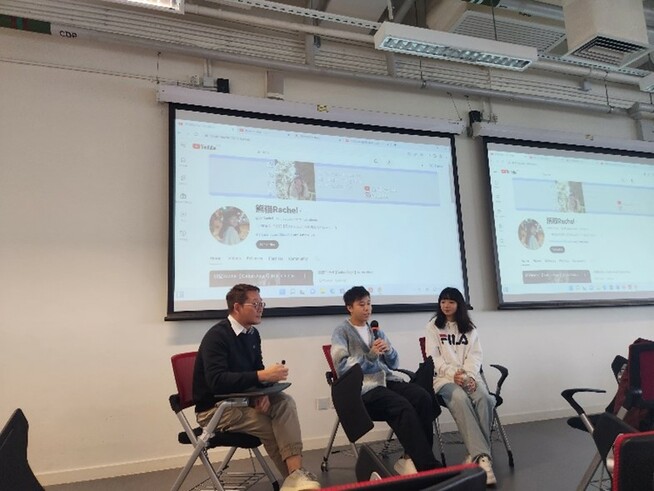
[375, 21, 538, 71]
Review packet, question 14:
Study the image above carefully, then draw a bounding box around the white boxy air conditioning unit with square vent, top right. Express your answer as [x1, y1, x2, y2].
[563, 0, 650, 68]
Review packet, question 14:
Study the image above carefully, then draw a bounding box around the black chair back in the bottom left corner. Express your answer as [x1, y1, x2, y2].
[0, 408, 44, 491]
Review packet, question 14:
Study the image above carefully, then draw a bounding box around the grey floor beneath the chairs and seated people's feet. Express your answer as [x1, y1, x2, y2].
[46, 419, 608, 491]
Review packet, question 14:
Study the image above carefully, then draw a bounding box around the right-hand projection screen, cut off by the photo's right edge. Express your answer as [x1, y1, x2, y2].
[484, 138, 654, 308]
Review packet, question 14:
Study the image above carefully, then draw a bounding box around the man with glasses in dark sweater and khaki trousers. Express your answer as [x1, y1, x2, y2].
[193, 284, 320, 491]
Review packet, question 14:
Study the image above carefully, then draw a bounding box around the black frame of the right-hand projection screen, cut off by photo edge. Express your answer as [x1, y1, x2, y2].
[482, 136, 654, 310]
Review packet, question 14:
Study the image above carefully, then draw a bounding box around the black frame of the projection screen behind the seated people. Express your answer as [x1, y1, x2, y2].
[164, 102, 469, 321]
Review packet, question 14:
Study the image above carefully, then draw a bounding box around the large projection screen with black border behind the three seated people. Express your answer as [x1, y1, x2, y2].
[166, 104, 468, 320]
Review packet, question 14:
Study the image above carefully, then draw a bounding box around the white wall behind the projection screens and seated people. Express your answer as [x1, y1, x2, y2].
[0, 29, 654, 484]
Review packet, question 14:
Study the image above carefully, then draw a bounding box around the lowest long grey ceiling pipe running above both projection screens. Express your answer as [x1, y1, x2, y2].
[59, 28, 640, 115]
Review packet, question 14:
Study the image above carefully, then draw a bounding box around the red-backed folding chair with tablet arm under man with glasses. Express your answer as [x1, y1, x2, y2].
[169, 351, 291, 491]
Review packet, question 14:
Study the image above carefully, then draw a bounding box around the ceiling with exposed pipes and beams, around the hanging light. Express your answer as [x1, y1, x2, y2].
[0, 0, 654, 112]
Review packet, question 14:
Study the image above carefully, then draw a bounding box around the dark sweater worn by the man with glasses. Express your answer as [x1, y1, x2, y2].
[193, 319, 264, 412]
